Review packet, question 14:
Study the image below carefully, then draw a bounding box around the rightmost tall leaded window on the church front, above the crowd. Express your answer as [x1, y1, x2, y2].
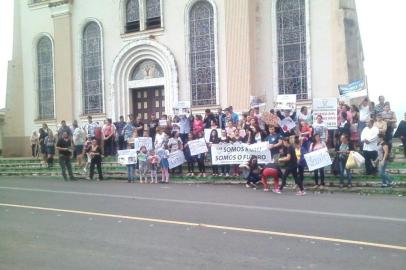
[276, 0, 308, 99]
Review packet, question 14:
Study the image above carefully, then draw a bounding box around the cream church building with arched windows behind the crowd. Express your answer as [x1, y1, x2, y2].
[3, 0, 365, 156]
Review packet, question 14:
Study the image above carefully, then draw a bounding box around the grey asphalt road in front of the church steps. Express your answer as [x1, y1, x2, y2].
[0, 177, 406, 270]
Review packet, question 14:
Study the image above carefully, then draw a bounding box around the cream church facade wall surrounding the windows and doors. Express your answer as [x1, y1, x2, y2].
[3, 0, 364, 156]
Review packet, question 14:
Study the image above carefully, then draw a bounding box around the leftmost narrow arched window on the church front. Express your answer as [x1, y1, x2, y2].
[37, 37, 55, 119]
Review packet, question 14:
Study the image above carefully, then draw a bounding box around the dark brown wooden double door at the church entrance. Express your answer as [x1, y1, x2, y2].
[131, 86, 165, 123]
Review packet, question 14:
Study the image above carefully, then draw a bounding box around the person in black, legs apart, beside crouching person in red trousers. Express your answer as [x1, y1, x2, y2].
[279, 138, 304, 195]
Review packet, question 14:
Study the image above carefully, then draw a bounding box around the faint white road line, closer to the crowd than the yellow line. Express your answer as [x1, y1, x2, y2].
[0, 186, 406, 222]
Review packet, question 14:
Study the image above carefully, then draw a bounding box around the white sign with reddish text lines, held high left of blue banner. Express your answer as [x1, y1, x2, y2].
[313, 98, 337, 129]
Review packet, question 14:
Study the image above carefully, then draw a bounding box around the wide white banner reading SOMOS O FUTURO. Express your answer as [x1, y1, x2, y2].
[211, 142, 272, 165]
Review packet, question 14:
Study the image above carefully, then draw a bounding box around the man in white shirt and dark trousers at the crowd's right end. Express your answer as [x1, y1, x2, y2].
[361, 120, 379, 175]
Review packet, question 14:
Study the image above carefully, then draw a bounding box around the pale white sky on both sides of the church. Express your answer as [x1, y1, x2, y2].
[0, 0, 406, 118]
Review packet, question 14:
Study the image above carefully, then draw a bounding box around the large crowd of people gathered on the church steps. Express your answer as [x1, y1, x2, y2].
[31, 96, 406, 192]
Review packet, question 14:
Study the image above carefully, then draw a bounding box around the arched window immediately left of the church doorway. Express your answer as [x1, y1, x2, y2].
[82, 22, 103, 114]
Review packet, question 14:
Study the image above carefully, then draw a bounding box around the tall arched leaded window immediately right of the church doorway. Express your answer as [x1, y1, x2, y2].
[189, 1, 217, 106]
